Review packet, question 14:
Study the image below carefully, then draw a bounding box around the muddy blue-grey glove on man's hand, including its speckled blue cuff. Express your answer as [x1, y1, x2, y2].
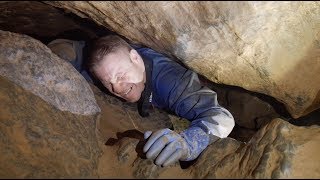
[143, 127, 209, 166]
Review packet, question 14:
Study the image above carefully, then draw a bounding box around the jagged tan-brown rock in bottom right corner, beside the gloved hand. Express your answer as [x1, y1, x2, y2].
[191, 119, 320, 178]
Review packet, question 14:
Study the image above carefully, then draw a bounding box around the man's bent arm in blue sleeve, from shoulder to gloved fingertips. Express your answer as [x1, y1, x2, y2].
[144, 49, 234, 164]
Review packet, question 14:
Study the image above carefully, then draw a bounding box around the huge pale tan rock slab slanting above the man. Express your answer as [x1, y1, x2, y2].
[45, 1, 320, 118]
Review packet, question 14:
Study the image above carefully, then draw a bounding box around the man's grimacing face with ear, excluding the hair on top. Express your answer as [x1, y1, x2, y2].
[94, 50, 146, 102]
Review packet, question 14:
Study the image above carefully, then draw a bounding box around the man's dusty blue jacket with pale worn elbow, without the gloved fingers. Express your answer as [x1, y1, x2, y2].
[135, 48, 234, 159]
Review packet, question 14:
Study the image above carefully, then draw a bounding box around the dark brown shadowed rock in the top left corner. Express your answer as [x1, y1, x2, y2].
[0, 1, 96, 41]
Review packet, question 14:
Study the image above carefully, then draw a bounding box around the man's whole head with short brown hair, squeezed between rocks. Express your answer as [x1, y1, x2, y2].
[89, 35, 146, 102]
